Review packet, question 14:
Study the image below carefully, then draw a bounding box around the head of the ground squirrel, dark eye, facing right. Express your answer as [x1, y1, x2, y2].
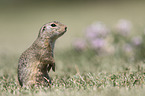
[38, 21, 67, 40]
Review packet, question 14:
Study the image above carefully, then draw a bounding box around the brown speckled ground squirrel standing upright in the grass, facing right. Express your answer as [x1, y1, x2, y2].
[18, 21, 67, 86]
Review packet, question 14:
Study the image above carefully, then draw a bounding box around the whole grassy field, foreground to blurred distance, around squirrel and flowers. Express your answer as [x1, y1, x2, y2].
[0, 0, 145, 96]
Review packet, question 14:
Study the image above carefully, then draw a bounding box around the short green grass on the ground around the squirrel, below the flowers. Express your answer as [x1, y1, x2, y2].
[0, 50, 145, 96]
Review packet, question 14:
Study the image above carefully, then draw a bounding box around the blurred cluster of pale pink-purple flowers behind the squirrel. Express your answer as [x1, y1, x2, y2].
[73, 19, 143, 56]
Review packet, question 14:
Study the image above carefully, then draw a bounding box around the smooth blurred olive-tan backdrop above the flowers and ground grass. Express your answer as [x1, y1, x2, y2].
[0, 0, 145, 54]
